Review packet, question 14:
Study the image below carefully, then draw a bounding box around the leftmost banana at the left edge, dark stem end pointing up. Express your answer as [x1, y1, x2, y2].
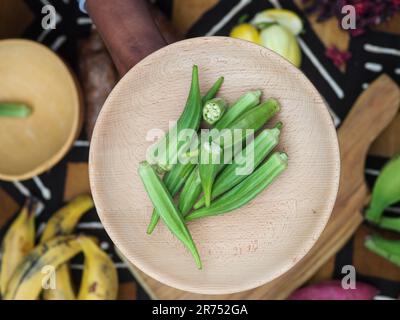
[0, 199, 37, 295]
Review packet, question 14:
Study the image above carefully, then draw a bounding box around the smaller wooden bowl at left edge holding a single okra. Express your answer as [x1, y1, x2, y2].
[0, 40, 81, 181]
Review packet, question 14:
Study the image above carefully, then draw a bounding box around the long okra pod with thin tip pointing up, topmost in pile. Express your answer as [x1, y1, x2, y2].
[150, 65, 202, 171]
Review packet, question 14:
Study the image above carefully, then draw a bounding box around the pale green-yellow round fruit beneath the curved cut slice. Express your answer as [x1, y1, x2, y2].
[261, 25, 301, 67]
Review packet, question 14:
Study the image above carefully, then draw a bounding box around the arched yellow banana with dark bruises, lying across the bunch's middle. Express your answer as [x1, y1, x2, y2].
[3, 236, 81, 300]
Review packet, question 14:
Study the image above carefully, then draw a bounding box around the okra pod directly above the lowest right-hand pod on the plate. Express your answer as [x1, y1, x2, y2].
[194, 122, 282, 209]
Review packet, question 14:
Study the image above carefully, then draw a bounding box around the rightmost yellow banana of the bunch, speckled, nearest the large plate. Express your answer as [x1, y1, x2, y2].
[78, 237, 118, 300]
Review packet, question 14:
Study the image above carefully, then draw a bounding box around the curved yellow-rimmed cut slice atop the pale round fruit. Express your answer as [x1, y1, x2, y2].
[251, 9, 303, 36]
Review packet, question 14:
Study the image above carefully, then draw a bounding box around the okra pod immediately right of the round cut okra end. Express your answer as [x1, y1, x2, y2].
[214, 90, 261, 130]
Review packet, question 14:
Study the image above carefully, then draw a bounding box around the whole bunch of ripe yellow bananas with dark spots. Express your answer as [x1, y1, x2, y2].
[0, 195, 118, 300]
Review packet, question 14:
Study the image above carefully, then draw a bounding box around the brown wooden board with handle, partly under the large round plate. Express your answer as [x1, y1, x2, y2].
[123, 75, 400, 299]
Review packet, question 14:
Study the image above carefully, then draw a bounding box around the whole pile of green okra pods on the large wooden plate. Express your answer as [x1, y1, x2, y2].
[138, 66, 288, 269]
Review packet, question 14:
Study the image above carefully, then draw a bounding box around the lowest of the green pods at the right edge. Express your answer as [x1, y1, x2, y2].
[364, 235, 400, 266]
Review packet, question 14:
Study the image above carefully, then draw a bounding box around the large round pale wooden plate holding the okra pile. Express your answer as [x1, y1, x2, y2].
[89, 37, 340, 294]
